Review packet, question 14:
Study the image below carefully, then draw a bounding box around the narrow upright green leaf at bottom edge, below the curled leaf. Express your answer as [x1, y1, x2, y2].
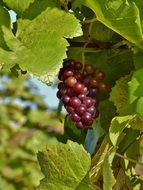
[102, 153, 116, 190]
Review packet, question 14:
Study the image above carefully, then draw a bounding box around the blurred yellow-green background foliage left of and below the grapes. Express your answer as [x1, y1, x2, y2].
[0, 72, 63, 190]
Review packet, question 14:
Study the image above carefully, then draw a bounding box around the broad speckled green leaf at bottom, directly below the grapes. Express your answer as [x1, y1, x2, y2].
[38, 141, 96, 190]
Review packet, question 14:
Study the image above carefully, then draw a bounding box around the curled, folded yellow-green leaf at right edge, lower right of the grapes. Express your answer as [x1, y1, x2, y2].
[109, 115, 143, 146]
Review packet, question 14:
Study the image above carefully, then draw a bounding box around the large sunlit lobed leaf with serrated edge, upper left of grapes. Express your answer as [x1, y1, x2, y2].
[0, 8, 82, 82]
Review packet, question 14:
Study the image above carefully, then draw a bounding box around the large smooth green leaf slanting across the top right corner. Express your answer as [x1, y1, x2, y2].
[83, 0, 143, 49]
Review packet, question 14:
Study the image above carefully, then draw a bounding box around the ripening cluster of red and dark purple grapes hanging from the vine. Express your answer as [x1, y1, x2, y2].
[57, 60, 107, 129]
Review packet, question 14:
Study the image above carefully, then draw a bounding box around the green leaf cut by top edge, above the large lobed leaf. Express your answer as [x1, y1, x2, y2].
[3, 0, 34, 14]
